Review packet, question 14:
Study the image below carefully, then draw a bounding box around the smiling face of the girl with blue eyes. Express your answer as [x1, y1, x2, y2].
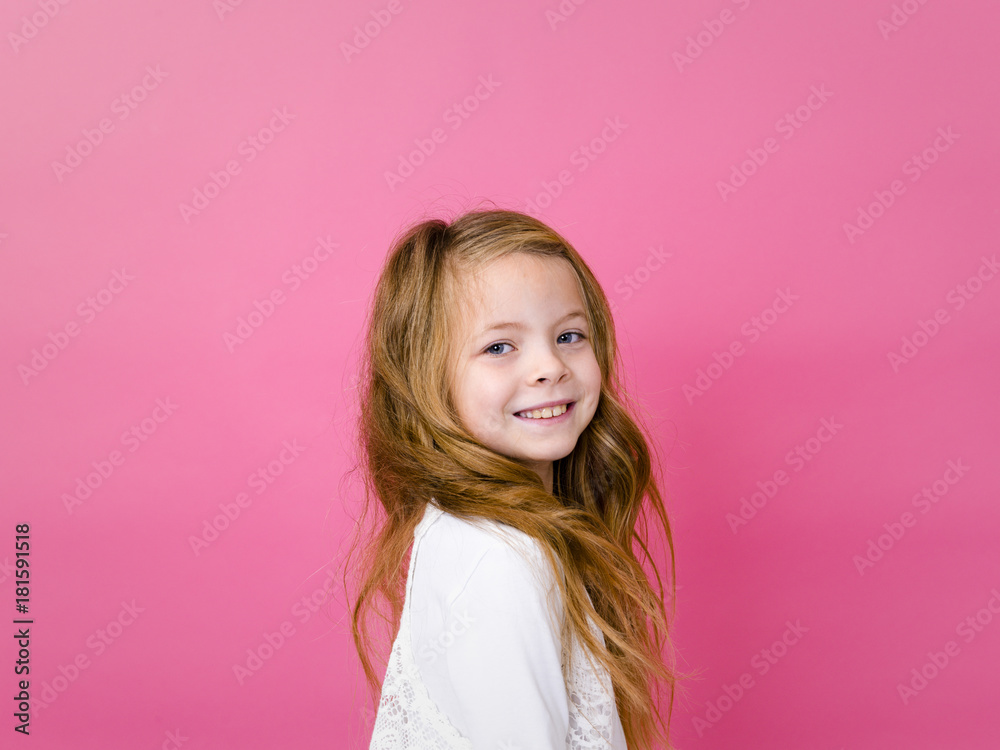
[449, 253, 601, 492]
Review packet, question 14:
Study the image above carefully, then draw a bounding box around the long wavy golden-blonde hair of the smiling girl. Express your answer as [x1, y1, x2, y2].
[344, 209, 676, 750]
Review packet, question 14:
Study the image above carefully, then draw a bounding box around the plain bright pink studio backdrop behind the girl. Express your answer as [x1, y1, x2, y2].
[0, 0, 1000, 750]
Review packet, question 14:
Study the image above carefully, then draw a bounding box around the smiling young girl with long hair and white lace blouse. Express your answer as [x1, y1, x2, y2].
[345, 210, 675, 750]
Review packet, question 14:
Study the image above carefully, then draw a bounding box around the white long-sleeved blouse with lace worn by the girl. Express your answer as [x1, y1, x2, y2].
[369, 500, 627, 750]
